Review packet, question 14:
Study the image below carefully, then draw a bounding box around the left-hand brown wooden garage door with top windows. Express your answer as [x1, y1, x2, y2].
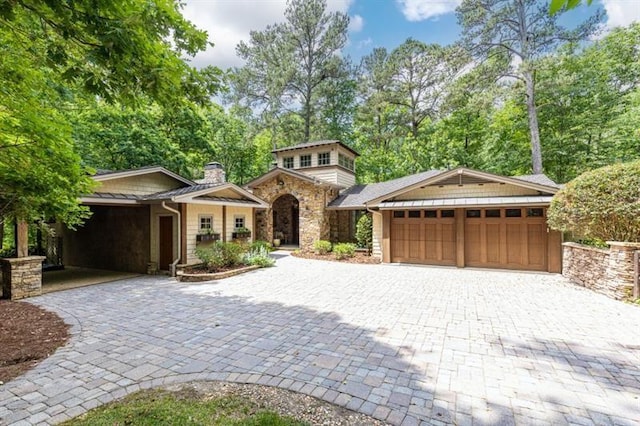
[391, 210, 456, 265]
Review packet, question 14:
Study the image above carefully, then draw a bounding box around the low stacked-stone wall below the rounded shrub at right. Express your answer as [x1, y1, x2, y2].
[562, 242, 640, 300]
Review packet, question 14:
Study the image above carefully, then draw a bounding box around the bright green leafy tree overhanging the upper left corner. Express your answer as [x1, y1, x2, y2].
[0, 0, 219, 256]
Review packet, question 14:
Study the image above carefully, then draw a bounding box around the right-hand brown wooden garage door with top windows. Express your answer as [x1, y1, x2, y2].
[464, 208, 547, 271]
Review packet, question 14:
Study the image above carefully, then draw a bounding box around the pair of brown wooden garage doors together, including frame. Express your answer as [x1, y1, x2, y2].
[387, 207, 560, 271]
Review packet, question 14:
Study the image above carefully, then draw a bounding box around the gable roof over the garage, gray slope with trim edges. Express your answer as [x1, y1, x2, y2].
[328, 167, 560, 210]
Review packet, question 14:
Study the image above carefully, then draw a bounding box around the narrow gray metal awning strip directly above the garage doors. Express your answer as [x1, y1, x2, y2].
[380, 195, 553, 210]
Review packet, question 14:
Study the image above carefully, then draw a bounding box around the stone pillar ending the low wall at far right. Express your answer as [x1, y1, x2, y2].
[605, 241, 640, 300]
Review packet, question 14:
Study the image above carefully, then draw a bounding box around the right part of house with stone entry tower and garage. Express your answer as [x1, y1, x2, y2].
[246, 140, 562, 272]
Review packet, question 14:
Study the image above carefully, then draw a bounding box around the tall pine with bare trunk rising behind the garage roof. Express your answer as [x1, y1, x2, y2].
[457, 0, 602, 173]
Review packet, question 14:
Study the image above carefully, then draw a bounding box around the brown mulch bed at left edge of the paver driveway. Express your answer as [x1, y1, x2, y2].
[0, 300, 69, 384]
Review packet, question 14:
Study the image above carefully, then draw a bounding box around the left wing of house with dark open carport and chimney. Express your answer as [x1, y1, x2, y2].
[58, 163, 268, 273]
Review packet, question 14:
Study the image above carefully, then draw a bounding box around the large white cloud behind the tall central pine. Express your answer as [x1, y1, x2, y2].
[182, 0, 356, 69]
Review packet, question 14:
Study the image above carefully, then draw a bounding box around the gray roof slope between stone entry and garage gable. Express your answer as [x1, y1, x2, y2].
[329, 170, 444, 209]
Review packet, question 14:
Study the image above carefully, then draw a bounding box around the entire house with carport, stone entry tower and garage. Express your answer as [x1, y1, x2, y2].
[62, 140, 562, 272]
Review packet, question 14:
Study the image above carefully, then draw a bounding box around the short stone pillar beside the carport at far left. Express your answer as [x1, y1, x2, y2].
[0, 256, 45, 300]
